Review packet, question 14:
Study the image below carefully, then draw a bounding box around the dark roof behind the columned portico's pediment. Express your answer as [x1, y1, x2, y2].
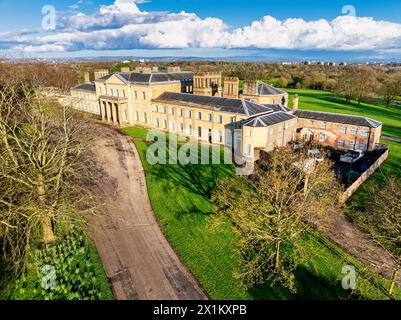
[98, 72, 193, 84]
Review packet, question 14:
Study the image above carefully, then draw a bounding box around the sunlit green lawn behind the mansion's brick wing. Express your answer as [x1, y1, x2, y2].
[285, 89, 401, 138]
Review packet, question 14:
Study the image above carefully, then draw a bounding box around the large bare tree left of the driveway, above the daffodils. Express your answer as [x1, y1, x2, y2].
[0, 77, 93, 271]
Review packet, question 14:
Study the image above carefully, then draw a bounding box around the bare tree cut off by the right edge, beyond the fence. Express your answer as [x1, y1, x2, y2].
[359, 177, 401, 294]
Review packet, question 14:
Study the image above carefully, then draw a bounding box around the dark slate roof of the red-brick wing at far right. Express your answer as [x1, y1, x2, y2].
[294, 110, 382, 128]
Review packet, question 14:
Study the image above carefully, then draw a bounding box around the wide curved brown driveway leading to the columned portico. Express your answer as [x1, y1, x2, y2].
[88, 126, 206, 300]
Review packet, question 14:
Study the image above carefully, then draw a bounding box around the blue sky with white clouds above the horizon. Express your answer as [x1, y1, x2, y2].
[0, 0, 401, 61]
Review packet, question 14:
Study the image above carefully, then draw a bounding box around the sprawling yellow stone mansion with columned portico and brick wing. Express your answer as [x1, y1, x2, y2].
[69, 67, 382, 158]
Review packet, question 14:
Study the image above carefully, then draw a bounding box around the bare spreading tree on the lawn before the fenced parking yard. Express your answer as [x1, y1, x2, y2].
[212, 149, 339, 292]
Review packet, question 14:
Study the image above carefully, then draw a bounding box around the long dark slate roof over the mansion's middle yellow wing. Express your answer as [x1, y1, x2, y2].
[153, 92, 273, 116]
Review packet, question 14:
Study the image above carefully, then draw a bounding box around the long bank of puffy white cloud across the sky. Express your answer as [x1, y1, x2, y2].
[4, 0, 401, 52]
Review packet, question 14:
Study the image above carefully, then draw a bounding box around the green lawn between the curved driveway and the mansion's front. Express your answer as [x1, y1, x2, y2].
[125, 128, 398, 299]
